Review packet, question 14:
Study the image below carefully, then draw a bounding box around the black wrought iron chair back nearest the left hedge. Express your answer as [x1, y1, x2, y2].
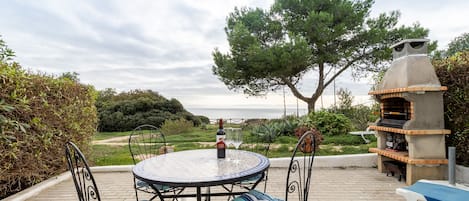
[65, 142, 101, 201]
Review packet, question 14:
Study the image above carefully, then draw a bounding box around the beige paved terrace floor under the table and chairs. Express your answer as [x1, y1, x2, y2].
[22, 168, 405, 201]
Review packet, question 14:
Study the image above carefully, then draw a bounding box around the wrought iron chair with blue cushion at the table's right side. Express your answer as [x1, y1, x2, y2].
[235, 131, 316, 201]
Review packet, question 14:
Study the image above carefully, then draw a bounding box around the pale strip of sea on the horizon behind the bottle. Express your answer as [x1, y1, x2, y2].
[187, 108, 308, 120]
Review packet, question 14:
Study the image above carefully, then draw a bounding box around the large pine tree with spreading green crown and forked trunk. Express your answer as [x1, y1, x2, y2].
[212, 0, 436, 112]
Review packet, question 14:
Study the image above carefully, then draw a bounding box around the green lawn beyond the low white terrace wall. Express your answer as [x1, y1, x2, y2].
[90, 127, 376, 166]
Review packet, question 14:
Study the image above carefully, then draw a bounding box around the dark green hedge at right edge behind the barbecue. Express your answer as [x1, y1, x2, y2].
[433, 51, 469, 166]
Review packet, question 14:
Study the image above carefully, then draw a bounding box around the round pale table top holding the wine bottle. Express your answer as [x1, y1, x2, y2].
[132, 149, 270, 187]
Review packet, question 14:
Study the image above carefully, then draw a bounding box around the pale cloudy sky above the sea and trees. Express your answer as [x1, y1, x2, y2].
[0, 0, 469, 108]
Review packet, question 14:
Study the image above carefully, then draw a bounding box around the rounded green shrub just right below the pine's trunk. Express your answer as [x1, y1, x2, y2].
[305, 110, 352, 136]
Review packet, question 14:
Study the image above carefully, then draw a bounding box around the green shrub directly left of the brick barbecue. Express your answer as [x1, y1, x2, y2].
[328, 89, 379, 130]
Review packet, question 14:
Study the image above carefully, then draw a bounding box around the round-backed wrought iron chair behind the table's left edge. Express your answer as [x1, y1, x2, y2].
[129, 124, 183, 201]
